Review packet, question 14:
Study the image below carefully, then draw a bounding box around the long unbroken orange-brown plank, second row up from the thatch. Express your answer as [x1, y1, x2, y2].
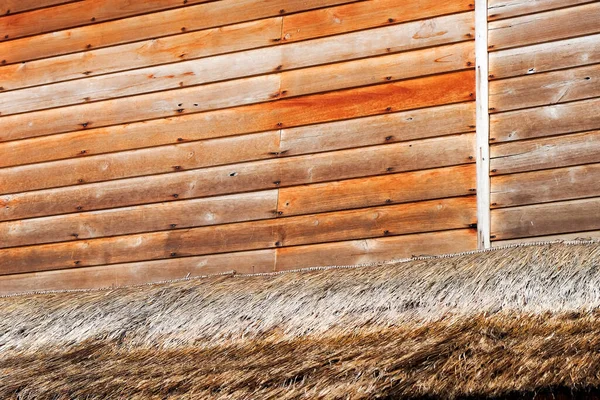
[0, 196, 476, 275]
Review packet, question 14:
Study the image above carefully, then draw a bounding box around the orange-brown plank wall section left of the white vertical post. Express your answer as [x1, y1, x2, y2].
[0, 0, 478, 293]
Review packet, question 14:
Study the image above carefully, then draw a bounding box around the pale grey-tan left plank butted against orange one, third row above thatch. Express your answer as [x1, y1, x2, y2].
[0, 190, 278, 248]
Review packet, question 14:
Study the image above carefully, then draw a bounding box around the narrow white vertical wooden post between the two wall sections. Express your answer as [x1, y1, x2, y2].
[475, 0, 491, 249]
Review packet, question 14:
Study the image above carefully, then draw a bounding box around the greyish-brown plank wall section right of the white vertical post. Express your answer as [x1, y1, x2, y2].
[488, 0, 600, 244]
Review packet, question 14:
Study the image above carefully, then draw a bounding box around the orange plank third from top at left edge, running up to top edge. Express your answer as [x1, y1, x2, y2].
[0, 0, 356, 65]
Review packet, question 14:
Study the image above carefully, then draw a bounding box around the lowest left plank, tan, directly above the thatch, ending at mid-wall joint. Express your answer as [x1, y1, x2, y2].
[0, 249, 275, 296]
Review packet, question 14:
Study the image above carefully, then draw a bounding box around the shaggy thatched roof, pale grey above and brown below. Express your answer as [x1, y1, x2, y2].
[0, 242, 600, 399]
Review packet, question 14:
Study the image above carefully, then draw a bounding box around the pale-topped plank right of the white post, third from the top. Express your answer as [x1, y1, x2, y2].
[489, 35, 600, 79]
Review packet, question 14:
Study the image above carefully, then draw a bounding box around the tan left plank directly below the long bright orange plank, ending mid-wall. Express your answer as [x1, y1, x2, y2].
[0, 131, 280, 194]
